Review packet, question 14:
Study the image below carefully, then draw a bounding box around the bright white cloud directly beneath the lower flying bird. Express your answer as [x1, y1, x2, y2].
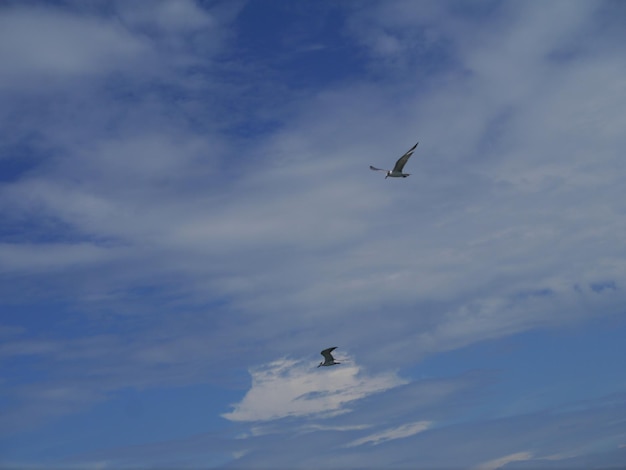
[222, 357, 406, 421]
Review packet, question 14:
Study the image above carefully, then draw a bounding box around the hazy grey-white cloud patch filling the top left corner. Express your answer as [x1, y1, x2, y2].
[0, 0, 232, 92]
